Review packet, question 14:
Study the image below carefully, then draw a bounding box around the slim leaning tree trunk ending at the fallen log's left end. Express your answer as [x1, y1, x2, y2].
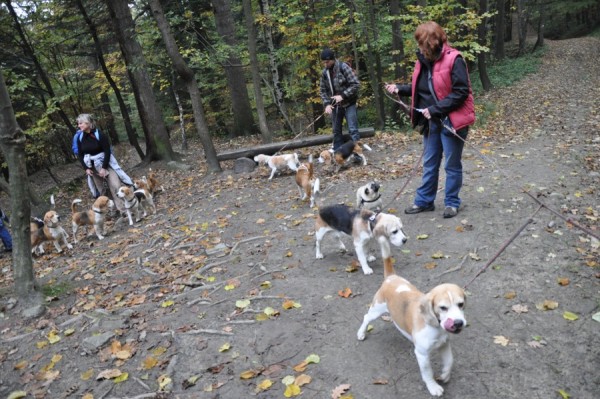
[149, 0, 221, 173]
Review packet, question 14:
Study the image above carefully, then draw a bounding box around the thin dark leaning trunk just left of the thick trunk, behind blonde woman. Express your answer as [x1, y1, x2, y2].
[75, 0, 144, 159]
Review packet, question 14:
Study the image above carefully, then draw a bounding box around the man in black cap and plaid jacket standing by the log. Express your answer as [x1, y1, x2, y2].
[320, 48, 360, 151]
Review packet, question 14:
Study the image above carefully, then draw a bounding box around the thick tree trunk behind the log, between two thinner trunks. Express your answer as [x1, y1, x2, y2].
[212, 0, 256, 136]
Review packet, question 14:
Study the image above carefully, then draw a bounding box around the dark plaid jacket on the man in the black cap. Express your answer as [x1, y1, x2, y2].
[320, 60, 360, 107]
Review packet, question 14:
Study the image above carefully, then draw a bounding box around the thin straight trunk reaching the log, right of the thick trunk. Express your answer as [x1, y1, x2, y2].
[242, 0, 273, 143]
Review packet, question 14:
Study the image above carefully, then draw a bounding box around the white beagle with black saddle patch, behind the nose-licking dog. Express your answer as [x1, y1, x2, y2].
[315, 204, 407, 274]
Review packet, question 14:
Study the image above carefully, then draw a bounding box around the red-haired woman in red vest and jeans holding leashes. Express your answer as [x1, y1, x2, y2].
[386, 21, 475, 218]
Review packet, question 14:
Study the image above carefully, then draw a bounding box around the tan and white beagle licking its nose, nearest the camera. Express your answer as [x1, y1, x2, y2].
[356, 264, 467, 396]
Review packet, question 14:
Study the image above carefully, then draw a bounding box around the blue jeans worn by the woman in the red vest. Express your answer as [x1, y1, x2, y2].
[415, 119, 466, 209]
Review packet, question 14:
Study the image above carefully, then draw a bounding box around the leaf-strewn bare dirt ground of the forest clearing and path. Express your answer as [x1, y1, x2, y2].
[0, 38, 600, 399]
